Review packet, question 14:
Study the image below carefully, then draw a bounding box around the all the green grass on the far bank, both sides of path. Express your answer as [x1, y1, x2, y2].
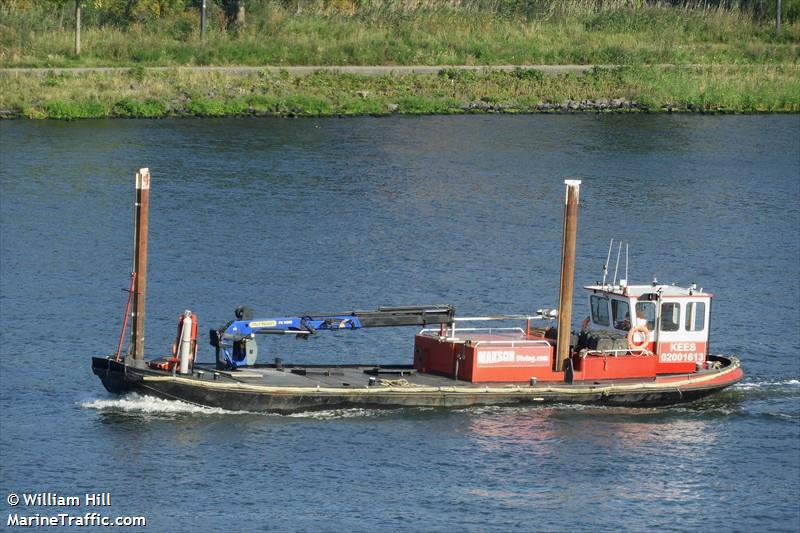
[0, 0, 800, 119]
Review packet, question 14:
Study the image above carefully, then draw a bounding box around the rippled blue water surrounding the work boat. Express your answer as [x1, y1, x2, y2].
[0, 115, 800, 531]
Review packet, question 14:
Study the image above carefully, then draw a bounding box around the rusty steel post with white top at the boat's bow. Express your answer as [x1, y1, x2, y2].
[131, 168, 150, 361]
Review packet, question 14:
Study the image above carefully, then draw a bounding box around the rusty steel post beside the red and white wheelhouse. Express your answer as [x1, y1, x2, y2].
[555, 180, 581, 371]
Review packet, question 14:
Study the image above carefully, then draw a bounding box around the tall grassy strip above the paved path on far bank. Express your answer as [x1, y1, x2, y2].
[0, 0, 800, 67]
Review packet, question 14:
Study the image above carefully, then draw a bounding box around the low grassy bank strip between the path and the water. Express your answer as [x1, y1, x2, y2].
[0, 65, 800, 119]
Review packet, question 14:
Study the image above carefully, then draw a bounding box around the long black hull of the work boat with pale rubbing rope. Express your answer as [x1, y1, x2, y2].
[92, 357, 742, 413]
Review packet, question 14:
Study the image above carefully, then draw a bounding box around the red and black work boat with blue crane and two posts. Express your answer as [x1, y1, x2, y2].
[92, 169, 743, 413]
